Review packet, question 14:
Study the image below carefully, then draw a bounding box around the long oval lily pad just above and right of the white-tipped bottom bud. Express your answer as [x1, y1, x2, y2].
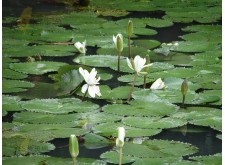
[122, 117, 187, 129]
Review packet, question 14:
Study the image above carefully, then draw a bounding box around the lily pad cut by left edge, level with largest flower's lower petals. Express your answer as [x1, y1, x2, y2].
[2, 79, 34, 93]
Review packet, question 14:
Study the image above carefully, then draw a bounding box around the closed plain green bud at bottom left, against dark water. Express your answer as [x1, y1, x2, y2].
[69, 134, 79, 158]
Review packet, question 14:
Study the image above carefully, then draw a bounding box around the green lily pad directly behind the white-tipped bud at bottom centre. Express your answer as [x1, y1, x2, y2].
[92, 122, 162, 137]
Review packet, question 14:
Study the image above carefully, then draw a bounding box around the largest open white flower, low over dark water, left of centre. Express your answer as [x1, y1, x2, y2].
[79, 67, 101, 98]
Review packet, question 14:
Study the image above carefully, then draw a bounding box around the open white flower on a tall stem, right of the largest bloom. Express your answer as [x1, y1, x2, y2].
[127, 55, 152, 74]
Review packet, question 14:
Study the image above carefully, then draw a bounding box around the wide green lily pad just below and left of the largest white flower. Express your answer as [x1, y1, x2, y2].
[22, 99, 99, 114]
